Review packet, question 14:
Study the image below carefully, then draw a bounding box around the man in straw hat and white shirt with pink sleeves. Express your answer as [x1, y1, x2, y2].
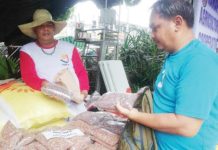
[19, 9, 89, 97]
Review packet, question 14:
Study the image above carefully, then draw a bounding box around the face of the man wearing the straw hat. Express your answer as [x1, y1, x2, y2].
[34, 22, 55, 41]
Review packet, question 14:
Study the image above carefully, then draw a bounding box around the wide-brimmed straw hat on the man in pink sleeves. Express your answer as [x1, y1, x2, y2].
[18, 9, 67, 39]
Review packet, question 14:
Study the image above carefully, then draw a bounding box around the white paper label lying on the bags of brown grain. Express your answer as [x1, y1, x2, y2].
[42, 129, 84, 140]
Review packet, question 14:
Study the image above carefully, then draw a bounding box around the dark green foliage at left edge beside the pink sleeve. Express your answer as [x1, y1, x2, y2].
[0, 54, 19, 80]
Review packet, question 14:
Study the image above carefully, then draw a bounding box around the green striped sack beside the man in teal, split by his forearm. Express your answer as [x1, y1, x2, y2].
[118, 87, 157, 150]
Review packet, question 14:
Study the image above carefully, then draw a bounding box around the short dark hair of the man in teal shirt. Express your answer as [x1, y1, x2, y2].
[152, 0, 194, 28]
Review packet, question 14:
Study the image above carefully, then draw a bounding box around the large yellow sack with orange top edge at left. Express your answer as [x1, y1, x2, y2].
[0, 81, 70, 129]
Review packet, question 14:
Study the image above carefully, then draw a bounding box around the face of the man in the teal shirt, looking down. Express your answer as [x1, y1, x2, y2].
[150, 12, 175, 52]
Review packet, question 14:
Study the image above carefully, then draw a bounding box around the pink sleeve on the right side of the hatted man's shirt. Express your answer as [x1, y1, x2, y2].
[72, 48, 89, 91]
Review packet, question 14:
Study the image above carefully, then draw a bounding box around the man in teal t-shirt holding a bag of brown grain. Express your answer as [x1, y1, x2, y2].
[117, 0, 218, 150]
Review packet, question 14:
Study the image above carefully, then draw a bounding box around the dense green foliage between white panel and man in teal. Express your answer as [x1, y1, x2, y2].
[120, 29, 165, 91]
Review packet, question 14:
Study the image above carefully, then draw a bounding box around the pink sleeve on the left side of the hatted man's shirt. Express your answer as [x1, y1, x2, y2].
[20, 51, 45, 91]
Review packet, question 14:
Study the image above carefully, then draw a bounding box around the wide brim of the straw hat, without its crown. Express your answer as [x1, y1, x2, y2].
[18, 20, 67, 39]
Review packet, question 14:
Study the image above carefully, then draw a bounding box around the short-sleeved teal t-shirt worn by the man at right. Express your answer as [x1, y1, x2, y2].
[154, 40, 218, 150]
